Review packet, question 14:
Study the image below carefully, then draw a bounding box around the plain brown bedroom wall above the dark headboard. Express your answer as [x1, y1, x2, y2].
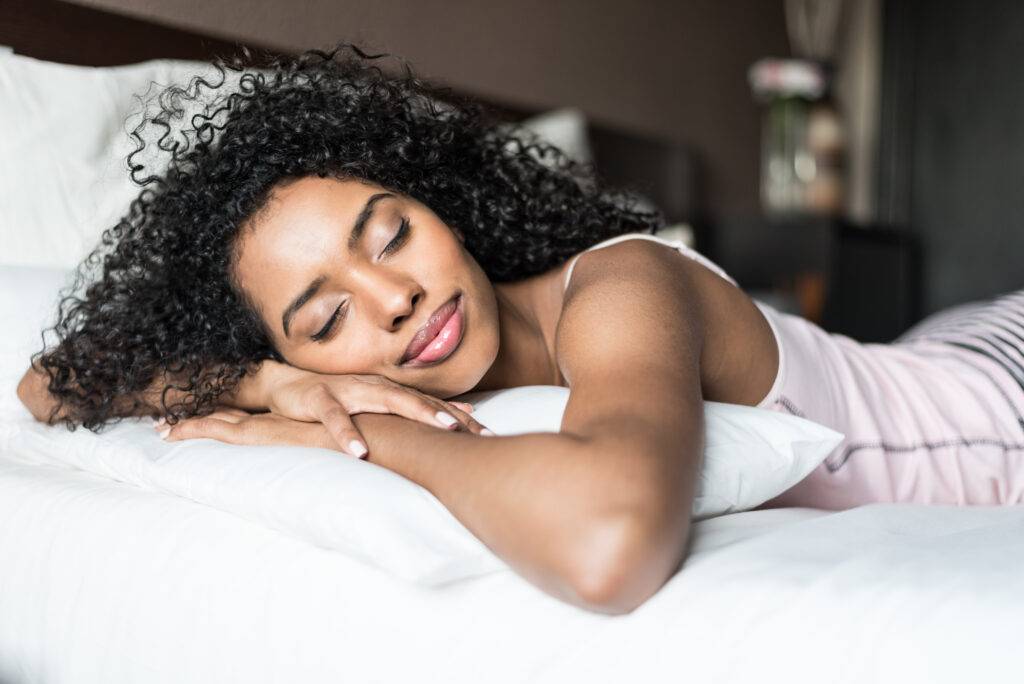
[61, 0, 788, 217]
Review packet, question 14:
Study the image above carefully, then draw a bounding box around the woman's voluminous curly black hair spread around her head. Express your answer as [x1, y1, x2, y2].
[33, 43, 665, 431]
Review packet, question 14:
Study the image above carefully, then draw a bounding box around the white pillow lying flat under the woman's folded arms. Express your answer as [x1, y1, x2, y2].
[0, 266, 843, 586]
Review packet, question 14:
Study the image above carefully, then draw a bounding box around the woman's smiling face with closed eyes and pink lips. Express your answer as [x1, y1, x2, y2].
[234, 176, 499, 397]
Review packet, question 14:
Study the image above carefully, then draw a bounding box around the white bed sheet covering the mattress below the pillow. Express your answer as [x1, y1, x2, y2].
[0, 446, 1024, 684]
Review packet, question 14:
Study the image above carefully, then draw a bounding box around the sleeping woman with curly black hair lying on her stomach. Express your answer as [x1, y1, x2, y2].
[18, 46, 1024, 613]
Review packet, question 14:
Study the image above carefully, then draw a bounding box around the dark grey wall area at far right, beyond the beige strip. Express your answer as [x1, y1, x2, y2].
[878, 0, 1024, 313]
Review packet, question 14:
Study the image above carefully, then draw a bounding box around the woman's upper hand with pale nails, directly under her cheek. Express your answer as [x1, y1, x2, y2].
[234, 360, 493, 457]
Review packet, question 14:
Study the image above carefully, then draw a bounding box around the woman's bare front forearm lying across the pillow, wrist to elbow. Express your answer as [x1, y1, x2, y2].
[344, 414, 647, 611]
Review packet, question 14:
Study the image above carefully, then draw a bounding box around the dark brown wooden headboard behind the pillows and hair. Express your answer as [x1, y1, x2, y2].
[0, 0, 701, 224]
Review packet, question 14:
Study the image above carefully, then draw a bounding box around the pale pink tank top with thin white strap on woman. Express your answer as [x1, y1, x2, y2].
[563, 233, 1024, 510]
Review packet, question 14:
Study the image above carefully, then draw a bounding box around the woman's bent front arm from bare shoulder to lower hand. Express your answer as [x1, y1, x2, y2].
[169, 241, 703, 613]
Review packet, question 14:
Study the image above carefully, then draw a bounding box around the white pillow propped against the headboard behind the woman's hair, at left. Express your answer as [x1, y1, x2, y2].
[0, 52, 253, 268]
